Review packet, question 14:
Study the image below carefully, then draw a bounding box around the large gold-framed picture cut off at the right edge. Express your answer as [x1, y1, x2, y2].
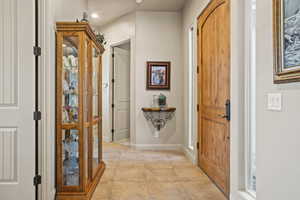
[273, 0, 300, 83]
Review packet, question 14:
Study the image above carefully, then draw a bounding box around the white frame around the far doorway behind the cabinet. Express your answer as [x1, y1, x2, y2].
[108, 38, 135, 144]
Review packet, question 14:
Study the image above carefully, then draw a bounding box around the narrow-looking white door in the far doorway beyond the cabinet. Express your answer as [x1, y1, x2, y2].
[114, 47, 130, 141]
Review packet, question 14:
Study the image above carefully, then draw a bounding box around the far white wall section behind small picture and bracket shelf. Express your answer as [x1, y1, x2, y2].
[135, 12, 184, 146]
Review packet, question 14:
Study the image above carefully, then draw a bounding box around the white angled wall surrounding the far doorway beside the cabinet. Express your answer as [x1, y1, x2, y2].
[97, 13, 135, 142]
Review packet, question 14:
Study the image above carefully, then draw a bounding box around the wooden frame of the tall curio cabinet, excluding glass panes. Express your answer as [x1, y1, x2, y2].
[56, 22, 105, 200]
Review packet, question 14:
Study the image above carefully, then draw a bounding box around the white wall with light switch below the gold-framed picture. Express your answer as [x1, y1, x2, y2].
[257, 0, 300, 200]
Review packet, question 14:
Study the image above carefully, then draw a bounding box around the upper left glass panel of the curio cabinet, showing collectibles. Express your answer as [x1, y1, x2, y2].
[62, 36, 79, 123]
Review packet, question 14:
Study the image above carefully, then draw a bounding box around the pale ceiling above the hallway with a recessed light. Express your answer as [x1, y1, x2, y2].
[88, 0, 186, 26]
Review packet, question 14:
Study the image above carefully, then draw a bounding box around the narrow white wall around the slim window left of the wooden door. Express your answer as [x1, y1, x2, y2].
[182, 0, 210, 163]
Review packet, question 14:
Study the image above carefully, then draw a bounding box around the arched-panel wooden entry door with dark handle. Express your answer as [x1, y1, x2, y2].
[198, 0, 230, 197]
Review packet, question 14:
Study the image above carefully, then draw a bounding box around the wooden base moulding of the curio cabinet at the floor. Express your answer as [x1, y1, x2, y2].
[55, 162, 105, 200]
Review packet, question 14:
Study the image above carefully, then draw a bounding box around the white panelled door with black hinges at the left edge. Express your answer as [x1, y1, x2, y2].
[0, 0, 35, 200]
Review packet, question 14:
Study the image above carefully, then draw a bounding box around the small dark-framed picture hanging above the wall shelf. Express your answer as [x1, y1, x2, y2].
[147, 62, 171, 90]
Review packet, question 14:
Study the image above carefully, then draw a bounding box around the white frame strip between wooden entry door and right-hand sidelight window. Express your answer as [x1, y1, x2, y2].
[230, 0, 255, 200]
